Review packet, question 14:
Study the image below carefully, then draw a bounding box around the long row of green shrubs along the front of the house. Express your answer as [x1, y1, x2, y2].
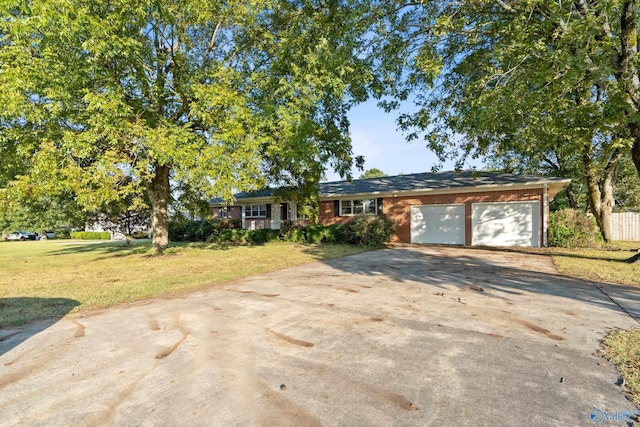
[169, 215, 395, 246]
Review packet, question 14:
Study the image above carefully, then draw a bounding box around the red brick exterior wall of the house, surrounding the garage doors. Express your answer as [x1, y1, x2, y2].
[318, 188, 548, 246]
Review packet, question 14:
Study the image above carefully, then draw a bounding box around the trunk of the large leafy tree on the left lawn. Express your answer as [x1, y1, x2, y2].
[146, 165, 171, 255]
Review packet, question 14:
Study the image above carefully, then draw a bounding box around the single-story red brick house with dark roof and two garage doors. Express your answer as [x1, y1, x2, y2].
[212, 171, 571, 247]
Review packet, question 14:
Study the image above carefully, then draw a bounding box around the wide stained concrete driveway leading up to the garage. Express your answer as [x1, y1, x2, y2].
[0, 246, 640, 426]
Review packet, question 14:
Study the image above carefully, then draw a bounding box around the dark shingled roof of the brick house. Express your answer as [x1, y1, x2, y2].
[212, 171, 570, 204]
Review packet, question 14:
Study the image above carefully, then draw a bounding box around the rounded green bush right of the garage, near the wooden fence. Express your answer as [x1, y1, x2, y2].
[549, 208, 602, 248]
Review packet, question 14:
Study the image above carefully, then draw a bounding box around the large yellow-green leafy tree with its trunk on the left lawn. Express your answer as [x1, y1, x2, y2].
[0, 0, 369, 252]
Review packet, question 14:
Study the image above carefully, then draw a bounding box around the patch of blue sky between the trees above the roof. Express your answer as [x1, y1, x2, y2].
[327, 100, 483, 181]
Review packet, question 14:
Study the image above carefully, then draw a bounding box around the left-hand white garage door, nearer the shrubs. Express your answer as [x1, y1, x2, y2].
[411, 205, 464, 245]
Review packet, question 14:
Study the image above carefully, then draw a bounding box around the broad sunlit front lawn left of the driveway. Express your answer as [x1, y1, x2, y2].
[0, 240, 365, 328]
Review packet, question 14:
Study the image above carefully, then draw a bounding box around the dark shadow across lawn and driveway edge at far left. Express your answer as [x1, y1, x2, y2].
[0, 297, 80, 356]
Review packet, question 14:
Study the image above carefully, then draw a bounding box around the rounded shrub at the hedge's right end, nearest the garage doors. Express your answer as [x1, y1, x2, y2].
[341, 215, 395, 246]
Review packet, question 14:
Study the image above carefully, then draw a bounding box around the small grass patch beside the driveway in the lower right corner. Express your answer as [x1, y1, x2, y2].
[601, 329, 640, 407]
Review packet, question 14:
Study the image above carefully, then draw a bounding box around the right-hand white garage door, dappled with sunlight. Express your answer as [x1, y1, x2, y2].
[471, 202, 540, 247]
